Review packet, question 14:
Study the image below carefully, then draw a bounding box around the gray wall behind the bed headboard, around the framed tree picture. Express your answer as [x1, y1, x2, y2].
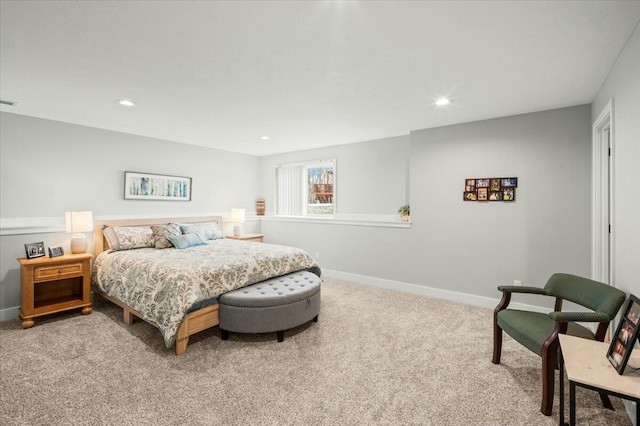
[0, 112, 260, 318]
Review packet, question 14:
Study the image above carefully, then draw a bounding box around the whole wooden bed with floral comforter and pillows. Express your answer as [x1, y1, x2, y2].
[92, 216, 320, 355]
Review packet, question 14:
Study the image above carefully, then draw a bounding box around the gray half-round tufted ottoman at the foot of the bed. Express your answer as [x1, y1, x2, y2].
[218, 271, 320, 342]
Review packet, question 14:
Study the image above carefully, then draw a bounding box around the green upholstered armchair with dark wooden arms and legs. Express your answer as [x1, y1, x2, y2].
[491, 274, 626, 416]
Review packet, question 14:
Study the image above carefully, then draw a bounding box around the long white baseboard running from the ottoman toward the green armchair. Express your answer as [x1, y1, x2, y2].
[322, 269, 553, 314]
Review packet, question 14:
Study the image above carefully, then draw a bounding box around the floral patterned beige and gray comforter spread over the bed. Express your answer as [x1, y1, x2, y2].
[92, 239, 320, 347]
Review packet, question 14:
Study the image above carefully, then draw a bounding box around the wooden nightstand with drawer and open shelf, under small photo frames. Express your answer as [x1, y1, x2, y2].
[18, 253, 93, 328]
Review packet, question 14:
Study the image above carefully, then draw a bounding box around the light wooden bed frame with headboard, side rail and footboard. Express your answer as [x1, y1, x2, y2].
[93, 216, 223, 355]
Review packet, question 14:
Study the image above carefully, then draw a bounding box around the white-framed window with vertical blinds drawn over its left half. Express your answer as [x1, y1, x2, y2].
[276, 160, 335, 216]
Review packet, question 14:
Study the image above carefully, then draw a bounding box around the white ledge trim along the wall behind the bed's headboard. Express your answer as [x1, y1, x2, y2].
[0, 212, 261, 236]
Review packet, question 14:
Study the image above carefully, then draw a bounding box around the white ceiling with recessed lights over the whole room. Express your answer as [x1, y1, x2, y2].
[0, 0, 640, 156]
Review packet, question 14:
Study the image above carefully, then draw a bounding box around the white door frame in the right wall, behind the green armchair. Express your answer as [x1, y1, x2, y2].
[591, 99, 615, 287]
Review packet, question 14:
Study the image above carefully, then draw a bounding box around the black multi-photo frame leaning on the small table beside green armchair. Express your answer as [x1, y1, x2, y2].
[607, 294, 640, 374]
